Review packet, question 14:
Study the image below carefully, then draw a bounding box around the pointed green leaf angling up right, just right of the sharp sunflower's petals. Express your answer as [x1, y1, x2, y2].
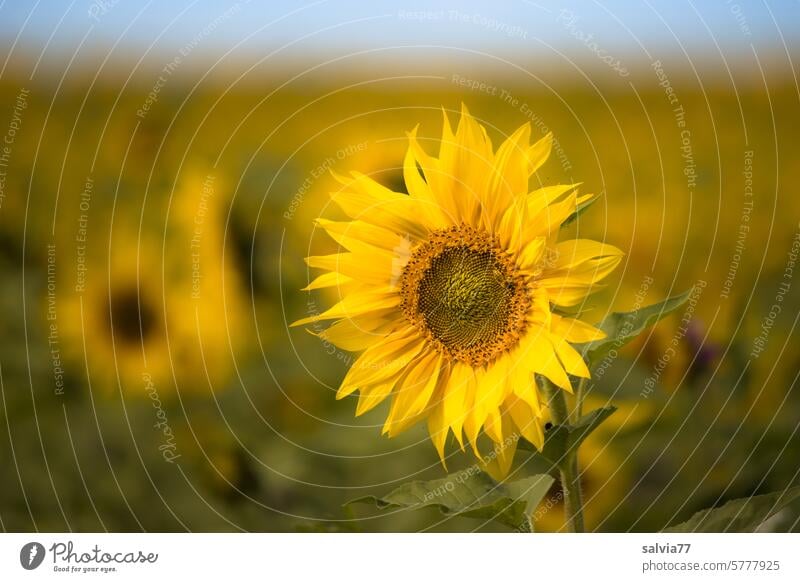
[582, 288, 694, 366]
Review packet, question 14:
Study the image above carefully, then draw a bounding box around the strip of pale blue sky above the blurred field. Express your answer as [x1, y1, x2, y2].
[0, 0, 800, 64]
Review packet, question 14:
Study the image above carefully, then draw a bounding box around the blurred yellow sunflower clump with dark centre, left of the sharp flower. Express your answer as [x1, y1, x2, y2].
[59, 171, 243, 396]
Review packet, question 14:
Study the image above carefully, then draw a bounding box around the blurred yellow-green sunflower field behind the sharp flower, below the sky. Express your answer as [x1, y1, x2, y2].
[0, 56, 800, 531]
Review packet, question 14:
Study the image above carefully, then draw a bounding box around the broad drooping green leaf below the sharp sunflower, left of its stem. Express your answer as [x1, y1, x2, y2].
[345, 474, 553, 530]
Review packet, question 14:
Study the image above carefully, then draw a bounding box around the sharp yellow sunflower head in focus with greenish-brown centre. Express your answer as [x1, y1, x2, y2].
[293, 106, 622, 475]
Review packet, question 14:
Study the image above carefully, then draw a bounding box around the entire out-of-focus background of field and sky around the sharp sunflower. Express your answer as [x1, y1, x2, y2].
[0, 0, 800, 531]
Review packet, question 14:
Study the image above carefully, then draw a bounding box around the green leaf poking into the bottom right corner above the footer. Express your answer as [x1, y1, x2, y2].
[664, 486, 800, 533]
